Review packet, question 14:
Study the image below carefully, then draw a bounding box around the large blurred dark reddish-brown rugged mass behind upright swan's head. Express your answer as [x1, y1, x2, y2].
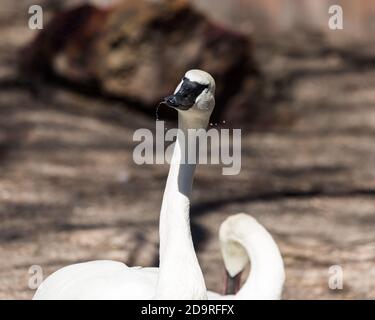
[22, 0, 256, 119]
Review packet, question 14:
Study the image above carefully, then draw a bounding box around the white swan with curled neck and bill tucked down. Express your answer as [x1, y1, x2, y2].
[209, 213, 285, 300]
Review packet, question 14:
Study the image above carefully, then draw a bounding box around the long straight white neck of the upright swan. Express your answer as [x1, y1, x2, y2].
[156, 111, 208, 299]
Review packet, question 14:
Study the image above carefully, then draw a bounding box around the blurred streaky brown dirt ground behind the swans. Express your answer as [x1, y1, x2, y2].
[0, 1, 375, 299]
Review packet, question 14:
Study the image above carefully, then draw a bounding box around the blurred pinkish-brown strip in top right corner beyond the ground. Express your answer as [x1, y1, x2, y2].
[197, 0, 375, 37]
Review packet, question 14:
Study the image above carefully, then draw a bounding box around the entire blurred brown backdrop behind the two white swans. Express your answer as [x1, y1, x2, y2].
[0, 0, 375, 299]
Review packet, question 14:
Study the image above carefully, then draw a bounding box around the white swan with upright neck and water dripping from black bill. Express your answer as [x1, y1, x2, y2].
[33, 70, 215, 299]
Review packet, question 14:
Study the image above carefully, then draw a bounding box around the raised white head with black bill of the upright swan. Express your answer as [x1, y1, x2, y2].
[164, 69, 215, 116]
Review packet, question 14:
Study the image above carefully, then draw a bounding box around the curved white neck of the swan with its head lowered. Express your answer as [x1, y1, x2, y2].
[222, 216, 285, 300]
